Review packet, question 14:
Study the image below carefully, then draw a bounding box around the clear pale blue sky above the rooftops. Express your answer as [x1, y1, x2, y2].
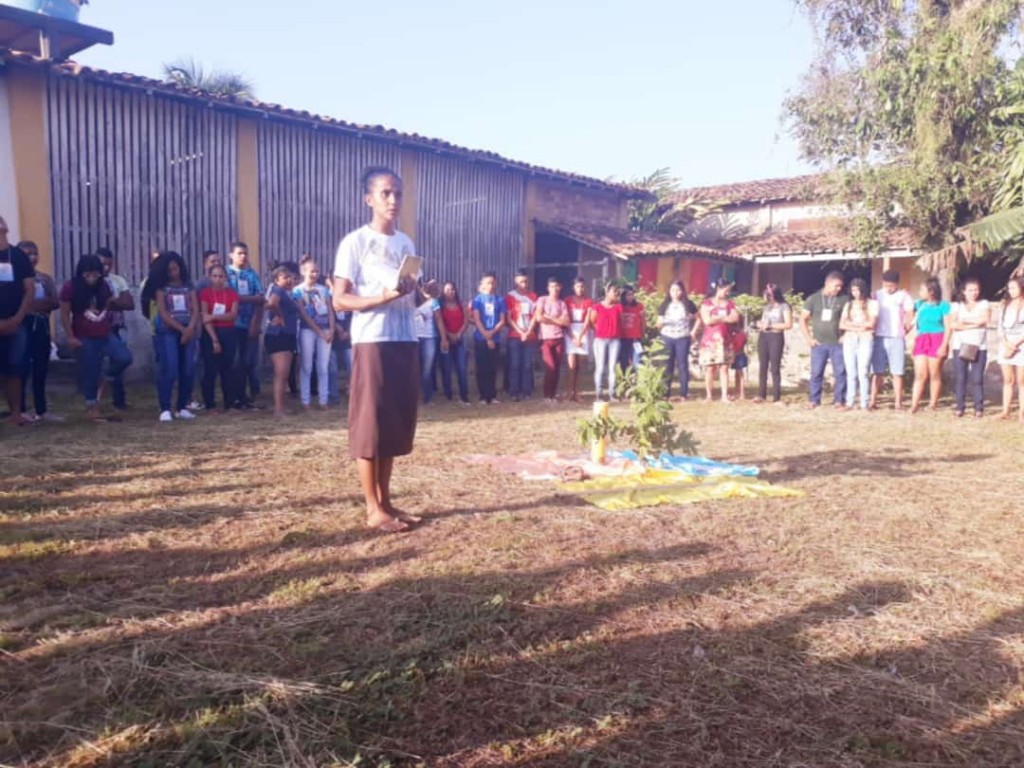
[78, 0, 811, 185]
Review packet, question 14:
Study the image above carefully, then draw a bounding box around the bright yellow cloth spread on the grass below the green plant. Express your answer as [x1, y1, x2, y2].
[559, 469, 803, 512]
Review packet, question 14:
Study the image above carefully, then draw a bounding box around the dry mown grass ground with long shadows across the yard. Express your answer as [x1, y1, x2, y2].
[0, 385, 1024, 768]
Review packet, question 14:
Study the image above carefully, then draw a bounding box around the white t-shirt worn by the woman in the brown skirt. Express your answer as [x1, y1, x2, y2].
[334, 225, 419, 344]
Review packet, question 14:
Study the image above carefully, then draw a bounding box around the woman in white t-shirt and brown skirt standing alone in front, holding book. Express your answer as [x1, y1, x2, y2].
[333, 168, 420, 532]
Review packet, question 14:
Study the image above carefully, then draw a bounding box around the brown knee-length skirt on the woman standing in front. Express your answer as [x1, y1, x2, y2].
[348, 341, 420, 459]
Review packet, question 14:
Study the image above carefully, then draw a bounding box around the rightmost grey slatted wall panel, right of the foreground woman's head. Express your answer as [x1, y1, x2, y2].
[416, 155, 526, 298]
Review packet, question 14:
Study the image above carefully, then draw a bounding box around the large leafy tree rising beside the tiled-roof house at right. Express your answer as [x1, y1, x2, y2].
[785, 0, 1024, 259]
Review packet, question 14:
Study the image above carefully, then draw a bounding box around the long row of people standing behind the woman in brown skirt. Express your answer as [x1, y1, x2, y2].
[0, 210, 1024, 424]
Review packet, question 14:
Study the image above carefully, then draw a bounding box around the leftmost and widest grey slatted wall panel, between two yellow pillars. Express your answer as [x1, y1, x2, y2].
[48, 76, 238, 285]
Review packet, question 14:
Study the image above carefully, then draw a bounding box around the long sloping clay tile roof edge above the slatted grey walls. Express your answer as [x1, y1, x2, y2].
[0, 48, 649, 198]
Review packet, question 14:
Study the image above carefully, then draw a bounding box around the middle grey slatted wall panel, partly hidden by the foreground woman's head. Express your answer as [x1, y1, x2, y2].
[259, 121, 401, 274]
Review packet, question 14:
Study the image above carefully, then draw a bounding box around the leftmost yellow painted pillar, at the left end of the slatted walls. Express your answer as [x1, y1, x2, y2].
[5, 68, 53, 274]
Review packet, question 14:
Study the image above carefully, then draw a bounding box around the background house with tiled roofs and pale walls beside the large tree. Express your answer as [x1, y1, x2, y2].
[679, 174, 925, 295]
